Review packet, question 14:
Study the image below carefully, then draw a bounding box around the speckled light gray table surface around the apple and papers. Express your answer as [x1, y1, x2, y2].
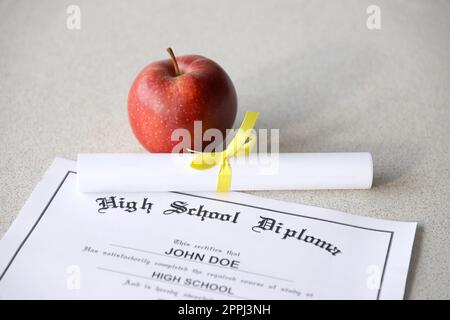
[0, 0, 450, 299]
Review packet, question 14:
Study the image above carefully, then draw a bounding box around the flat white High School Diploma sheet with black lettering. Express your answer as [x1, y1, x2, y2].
[0, 159, 416, 299]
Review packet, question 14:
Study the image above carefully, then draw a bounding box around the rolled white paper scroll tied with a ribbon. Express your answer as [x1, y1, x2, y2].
[77, 152, 373, 192]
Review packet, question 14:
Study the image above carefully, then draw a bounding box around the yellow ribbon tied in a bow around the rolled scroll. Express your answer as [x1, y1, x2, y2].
[190, 112, 259, 192]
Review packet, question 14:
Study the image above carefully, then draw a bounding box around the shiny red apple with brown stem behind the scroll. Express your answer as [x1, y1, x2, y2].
[128, 48, 237, 152]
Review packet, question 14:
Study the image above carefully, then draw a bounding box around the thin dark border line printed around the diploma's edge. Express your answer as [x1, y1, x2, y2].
[0, 170, 394, 300]
